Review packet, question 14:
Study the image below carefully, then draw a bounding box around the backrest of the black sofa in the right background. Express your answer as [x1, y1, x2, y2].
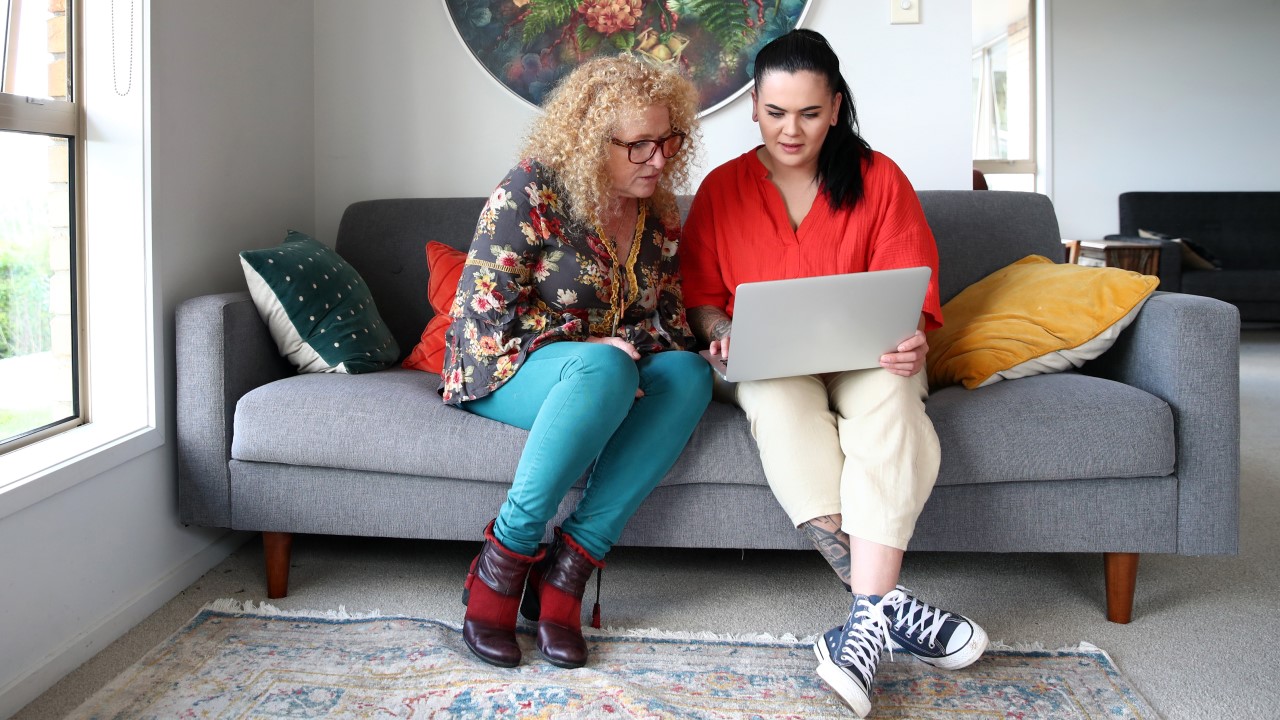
[1120, 192, 1280, 269]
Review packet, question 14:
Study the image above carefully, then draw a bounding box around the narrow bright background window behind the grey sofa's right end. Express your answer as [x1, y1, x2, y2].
[972, 0, 1037, 191]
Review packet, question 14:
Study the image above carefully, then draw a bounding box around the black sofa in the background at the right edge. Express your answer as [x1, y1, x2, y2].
[1108, 192, 1280, 323]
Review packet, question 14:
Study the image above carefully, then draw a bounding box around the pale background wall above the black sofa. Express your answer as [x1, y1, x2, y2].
[1048, 0, 1280, 238]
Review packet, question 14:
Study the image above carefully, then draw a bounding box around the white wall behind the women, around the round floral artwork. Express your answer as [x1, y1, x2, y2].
[315, 0, 972, 243]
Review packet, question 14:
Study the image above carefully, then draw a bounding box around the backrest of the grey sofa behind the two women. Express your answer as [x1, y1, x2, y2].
[335, 190, 1062, 355]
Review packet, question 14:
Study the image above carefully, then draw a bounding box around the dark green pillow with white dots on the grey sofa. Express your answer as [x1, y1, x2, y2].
[241, 231, 399, 374]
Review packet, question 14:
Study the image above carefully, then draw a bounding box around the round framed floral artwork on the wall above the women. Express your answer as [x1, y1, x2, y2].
[443, 0, 813, 115]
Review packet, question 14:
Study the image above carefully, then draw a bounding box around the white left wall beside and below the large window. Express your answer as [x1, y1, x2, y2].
[0, 0, 315, 717]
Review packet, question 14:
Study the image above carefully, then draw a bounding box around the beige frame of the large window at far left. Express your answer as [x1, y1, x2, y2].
[0, 0, 90, 450]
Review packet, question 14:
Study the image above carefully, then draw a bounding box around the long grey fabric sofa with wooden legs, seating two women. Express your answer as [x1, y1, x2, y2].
[177, 191, 1239, 621]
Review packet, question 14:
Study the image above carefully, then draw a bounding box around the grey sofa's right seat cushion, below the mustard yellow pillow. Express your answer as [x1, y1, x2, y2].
[928, 372, 1174, 486]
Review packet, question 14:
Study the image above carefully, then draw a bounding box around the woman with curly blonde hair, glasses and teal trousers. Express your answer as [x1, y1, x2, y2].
[442, 56, 712, 667]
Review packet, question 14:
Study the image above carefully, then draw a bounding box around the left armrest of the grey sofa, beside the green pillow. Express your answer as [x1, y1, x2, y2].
[174, 292, 294, 528]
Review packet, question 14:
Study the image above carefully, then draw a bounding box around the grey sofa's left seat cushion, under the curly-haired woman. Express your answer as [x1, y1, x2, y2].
[232, 368, 747, 484]
